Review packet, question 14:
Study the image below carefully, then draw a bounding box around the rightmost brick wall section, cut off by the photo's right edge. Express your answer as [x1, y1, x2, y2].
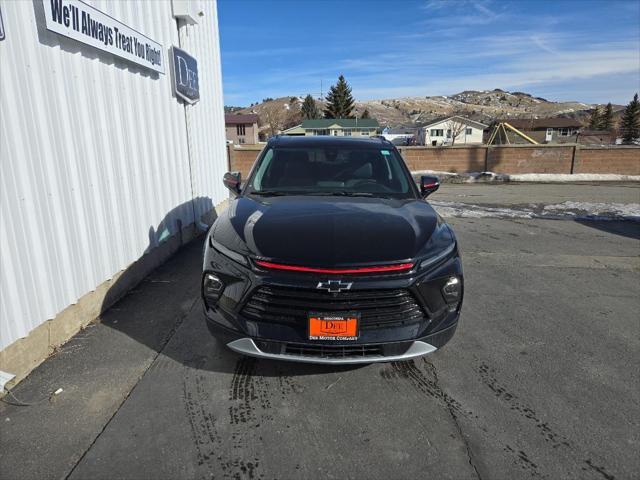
[573, 146, 640, 175]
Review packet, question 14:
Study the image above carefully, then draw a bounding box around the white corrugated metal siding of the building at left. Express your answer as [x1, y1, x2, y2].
[0, 1, 227, 349]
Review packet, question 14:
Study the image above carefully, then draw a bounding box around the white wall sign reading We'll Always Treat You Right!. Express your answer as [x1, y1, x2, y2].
[42, 0, 165, 73]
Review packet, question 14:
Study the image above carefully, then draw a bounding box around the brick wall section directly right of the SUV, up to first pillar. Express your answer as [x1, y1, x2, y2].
[400, 147, 486, 173]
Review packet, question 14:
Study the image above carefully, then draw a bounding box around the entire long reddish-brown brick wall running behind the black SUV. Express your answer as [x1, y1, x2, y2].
[228, 145, 640, 178]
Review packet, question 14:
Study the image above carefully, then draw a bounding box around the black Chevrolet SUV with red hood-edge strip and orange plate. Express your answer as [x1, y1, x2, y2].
[202, 137, 464, 363]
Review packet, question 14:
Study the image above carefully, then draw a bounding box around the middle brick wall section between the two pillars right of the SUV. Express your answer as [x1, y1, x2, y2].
[487, 146, 573, 173]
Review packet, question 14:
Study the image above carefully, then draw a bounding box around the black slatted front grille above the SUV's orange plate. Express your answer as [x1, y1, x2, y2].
[242, 286, 425, 330]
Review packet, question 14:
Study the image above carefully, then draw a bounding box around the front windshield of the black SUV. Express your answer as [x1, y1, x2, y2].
[248, 148, 414, 198]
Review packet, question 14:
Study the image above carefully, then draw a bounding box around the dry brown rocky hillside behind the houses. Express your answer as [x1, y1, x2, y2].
[238, 89, 624, 131]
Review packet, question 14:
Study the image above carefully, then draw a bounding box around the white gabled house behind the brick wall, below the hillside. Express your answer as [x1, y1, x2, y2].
[418, 115, 488, 147]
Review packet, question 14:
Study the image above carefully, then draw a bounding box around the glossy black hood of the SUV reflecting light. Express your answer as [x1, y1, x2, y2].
[212, 196, 451, 266]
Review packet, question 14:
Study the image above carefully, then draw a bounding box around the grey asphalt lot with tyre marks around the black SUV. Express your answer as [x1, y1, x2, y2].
[0, 184, 640, 480]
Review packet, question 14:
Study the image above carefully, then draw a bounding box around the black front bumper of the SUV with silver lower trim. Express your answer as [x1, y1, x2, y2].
[204, 236, 463, 364]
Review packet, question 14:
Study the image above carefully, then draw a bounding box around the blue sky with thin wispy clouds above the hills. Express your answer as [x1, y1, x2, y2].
[218, 0, 640, 106]
